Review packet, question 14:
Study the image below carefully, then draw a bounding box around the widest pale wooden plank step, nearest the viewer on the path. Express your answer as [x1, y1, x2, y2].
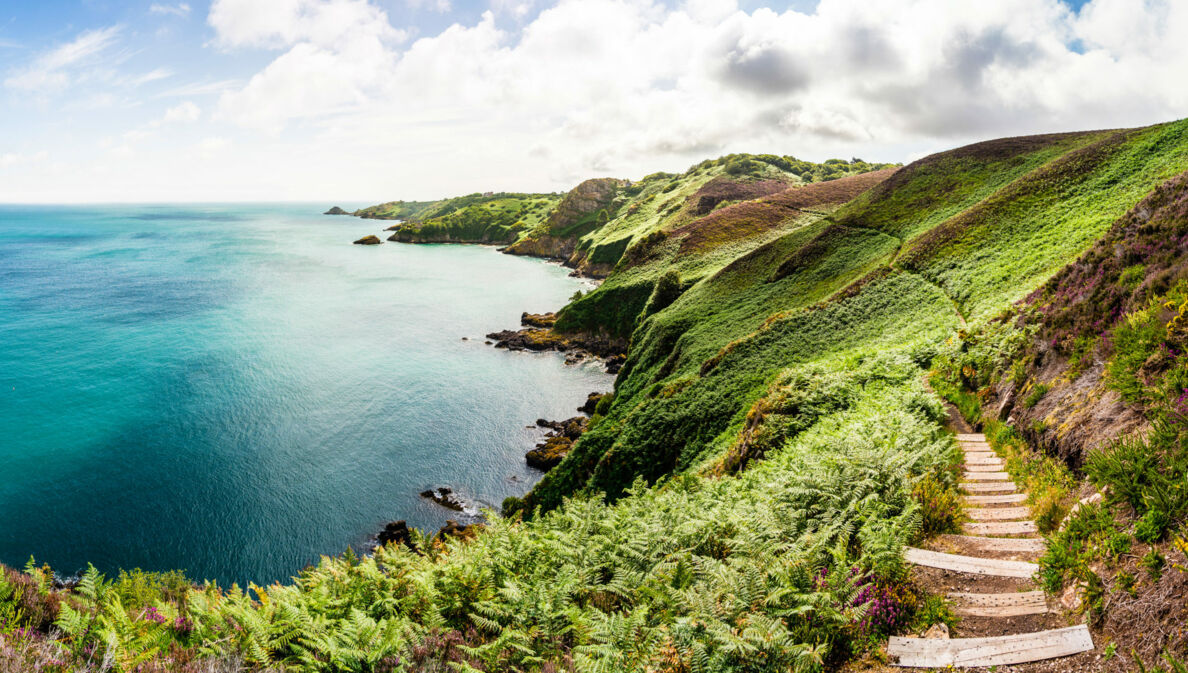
[887, 624, 1093, 668]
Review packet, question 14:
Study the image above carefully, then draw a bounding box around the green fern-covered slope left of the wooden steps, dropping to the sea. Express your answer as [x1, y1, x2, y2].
[0, 122, 1188, 672]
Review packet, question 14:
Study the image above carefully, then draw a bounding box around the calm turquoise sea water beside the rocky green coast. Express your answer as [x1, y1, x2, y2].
[0, 205, 612, 583]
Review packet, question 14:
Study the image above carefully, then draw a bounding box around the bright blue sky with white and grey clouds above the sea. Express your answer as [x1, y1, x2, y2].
[0, 0, 1188, 203]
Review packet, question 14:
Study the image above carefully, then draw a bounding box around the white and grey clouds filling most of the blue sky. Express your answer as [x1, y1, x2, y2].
[5, 0, 1188, 201]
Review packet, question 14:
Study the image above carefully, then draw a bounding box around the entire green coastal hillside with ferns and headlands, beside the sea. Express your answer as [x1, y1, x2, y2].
[0, 121, 1188, 673]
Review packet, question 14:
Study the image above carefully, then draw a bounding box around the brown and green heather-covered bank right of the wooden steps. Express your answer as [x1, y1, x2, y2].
[926, 161, 1188, 665]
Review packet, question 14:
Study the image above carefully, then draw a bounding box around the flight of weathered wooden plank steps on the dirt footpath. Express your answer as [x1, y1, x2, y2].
[887, 434, 1093, 668]
